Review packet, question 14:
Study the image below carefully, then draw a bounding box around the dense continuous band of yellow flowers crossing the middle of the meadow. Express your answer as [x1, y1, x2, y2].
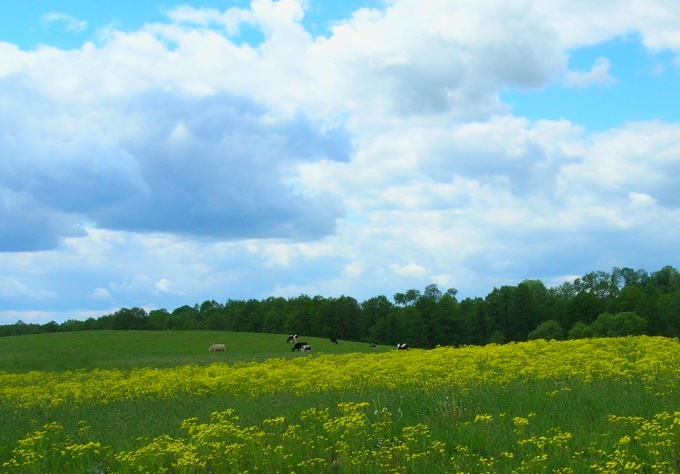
[0, 337, 680, 407]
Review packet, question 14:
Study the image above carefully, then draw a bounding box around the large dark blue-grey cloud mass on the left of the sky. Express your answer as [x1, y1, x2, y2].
[0, 31, 350, 250]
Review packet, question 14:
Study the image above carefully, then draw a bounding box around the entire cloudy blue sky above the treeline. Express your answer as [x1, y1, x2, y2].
[0, 0, 680, 324]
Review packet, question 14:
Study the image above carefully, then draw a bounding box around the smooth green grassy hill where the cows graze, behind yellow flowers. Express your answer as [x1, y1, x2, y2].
[0, 331, 393, 373]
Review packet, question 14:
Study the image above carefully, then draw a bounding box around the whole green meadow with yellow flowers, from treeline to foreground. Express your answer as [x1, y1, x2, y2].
[0, 331, 680, 473]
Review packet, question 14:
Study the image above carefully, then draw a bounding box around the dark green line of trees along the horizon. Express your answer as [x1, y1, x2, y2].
[0, 266, 680, 348]
